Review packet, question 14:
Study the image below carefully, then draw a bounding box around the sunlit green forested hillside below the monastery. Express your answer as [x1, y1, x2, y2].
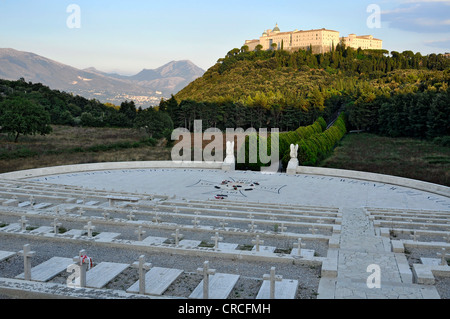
[171, 46, 450, 137]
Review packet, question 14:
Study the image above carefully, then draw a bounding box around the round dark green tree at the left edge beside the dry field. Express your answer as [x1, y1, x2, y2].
[0, 97, 52, 143]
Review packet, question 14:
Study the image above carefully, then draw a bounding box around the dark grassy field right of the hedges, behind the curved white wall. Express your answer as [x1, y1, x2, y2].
[320, 133, 450, 186]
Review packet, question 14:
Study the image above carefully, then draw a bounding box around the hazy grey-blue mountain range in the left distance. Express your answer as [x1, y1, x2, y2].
[0, 48, 205, 106]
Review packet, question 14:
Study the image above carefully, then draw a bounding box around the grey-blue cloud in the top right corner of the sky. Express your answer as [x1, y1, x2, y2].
[382, 0, 450, 33]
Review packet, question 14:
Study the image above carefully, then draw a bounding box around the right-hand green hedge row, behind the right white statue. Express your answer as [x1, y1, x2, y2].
[298, 115, 347, 166]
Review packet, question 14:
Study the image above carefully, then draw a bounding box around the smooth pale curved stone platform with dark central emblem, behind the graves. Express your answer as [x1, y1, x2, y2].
[28, 168, 450, 210]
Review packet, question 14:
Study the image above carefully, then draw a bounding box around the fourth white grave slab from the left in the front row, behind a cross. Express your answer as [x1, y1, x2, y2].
[189, 273, 239, 299]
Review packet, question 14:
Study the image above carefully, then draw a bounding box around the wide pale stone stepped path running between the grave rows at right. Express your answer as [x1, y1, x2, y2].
[319, 208, 440, 299]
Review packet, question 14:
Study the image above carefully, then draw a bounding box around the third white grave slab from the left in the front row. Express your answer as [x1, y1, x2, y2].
[127, 267, 183, 296]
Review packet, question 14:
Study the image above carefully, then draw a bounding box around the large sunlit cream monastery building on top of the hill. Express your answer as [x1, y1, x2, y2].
[245, 24, 383, 53]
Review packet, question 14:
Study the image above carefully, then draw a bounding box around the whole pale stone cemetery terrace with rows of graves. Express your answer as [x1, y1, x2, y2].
[0, 168, 450, 299]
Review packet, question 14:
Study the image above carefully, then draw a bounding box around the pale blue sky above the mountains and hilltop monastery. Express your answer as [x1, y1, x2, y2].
[0, 0, 450, 75]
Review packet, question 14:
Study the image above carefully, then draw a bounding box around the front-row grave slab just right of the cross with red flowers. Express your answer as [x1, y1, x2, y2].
[84, 262, 130, 289]
